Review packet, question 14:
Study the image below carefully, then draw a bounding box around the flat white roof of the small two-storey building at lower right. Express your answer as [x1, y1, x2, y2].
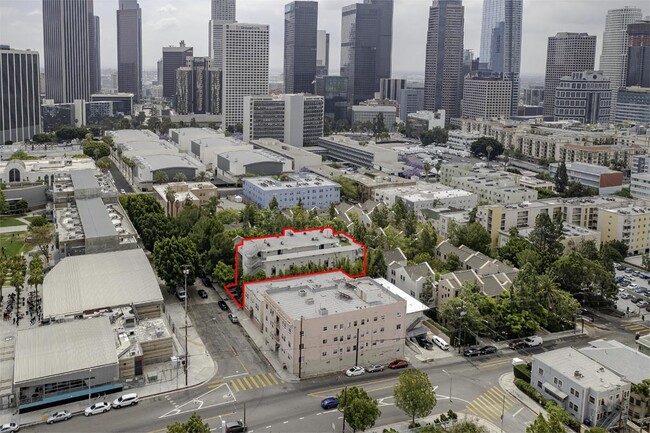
[533, 347, 627, 392]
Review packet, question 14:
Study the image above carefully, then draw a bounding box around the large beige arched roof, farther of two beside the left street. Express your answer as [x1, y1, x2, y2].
[43, 249, 163, 318]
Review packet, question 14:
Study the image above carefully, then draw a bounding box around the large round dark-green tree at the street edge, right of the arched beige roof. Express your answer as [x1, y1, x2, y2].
[153, 236, 199, 288]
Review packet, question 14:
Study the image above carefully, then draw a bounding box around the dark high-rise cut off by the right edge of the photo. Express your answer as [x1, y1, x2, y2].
[617, 21, 650, 88]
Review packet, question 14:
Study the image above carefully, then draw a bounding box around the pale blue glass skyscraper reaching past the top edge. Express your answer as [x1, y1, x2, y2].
[479, 0, 523, 116]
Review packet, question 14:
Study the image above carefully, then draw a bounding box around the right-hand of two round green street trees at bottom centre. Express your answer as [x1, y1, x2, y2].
[393, 369, 437, 424]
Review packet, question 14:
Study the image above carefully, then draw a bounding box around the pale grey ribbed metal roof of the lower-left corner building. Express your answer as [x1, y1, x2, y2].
[14, 317, 117, 385]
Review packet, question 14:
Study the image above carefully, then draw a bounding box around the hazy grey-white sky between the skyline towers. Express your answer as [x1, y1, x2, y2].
[0, 0, 649, 75]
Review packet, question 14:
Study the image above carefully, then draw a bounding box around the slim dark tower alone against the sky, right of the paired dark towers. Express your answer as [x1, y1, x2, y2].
[117, 0, 142, 102]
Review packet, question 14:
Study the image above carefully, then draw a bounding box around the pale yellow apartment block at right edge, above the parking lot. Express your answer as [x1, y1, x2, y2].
[598, 205, 650, 255]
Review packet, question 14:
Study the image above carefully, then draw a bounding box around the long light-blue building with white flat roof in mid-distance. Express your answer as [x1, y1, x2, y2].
[243, 173, 341, 209]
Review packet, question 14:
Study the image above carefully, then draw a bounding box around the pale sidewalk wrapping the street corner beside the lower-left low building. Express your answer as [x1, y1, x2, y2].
[0, 303, 217, 426]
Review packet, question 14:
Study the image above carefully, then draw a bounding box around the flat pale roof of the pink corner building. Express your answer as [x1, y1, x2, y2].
[246, 271, 406, 320]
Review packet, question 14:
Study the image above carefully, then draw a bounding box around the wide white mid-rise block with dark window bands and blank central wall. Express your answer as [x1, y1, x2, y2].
[243, 94, 324, 147]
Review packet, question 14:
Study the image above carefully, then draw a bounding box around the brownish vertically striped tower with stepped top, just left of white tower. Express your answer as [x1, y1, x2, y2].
[175, 57, 221, 114]
